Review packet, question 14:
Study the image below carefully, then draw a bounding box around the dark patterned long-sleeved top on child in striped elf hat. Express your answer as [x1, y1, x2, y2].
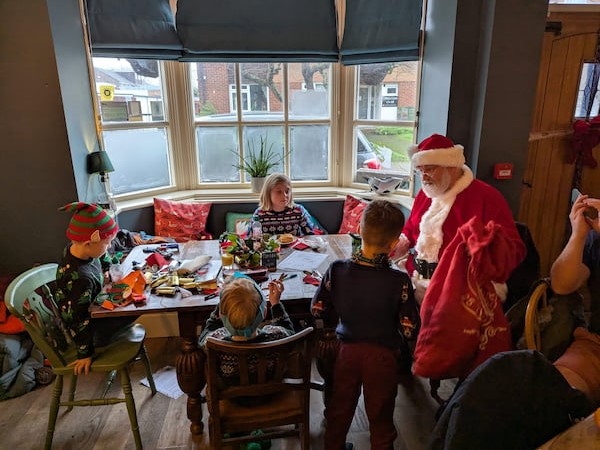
[54, 245, 104, 359]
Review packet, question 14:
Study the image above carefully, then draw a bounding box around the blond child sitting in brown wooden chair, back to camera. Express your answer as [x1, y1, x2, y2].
[198, 272, 294, 384]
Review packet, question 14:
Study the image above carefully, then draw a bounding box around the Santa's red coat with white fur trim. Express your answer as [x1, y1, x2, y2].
[402, 166, 526, 274]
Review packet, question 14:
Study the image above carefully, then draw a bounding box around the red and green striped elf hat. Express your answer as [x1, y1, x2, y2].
[58, 202, 119, 242]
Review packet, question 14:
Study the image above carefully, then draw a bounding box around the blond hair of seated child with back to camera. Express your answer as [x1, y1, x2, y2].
[219, 278, 262, 329]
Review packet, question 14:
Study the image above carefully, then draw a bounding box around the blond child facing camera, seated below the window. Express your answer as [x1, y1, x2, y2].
[249, 173, 324, 236]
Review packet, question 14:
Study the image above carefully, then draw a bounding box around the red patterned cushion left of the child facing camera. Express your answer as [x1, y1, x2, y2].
[154, 198, 212, 242]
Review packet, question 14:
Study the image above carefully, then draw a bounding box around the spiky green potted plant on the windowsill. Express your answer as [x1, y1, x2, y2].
[233, 136, 285, 193]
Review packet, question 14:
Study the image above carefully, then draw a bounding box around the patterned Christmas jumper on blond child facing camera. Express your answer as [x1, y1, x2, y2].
[252, 204, 320, 236]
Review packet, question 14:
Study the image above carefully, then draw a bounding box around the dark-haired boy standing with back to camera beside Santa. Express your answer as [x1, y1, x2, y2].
[311, 200, 420, 450]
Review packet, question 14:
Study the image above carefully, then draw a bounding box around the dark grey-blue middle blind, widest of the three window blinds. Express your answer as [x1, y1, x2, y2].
[177, 0, 338, 62]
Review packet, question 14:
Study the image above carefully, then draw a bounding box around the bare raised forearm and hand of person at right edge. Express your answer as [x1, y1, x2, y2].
[550, 195, 600, 294]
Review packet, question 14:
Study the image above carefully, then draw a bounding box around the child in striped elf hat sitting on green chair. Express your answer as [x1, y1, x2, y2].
[54, 202, 125, 375]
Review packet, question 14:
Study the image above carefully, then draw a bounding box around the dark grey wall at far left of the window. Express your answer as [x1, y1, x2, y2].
[0, 0, 77, 273]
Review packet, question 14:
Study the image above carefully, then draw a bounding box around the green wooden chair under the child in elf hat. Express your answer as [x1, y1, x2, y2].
[5, 264, 156, 450]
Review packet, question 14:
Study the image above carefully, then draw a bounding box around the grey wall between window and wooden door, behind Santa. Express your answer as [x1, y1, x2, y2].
[419, 0, 547, 215]
